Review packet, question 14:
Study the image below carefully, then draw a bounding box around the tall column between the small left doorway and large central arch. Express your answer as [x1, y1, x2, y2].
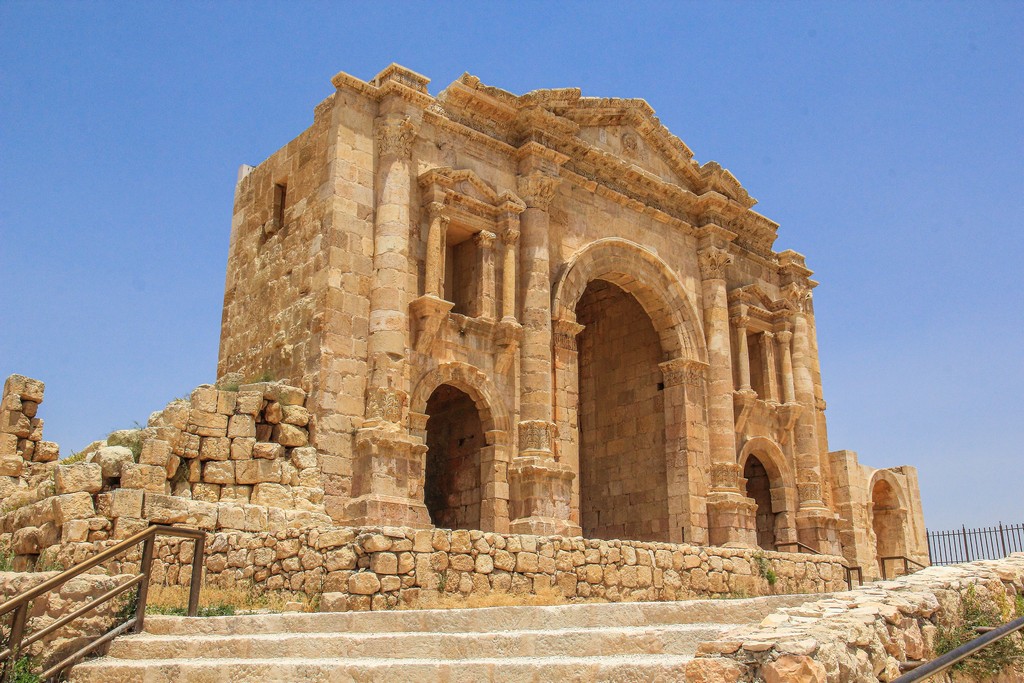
[509, 141, 580, 536]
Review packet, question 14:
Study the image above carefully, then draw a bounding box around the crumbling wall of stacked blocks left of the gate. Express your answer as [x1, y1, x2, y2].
[0, 375, 330, 569]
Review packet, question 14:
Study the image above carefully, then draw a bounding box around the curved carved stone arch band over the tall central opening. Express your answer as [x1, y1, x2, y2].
[551, 238, 708, 362]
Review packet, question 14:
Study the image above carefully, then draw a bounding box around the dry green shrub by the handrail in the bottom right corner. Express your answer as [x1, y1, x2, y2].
[935, 586, 1024, 679]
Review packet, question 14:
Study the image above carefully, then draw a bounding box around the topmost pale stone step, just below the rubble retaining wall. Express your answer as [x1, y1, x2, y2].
[145, 594, 830, 635]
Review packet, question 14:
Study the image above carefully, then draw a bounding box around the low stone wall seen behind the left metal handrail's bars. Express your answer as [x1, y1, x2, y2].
[0, 571, 134, 670]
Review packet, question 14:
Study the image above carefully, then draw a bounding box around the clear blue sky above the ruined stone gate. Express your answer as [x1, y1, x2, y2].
[0, 0, 1024, 527]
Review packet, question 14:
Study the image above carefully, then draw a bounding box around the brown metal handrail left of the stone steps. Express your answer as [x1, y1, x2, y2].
[0, 524, 206, 683]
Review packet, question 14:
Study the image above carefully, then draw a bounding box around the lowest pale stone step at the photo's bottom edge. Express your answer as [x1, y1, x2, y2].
[69, 654, 691, 683]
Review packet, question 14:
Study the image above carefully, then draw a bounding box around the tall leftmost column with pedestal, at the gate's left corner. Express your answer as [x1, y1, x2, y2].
[346, 107, 430, 527]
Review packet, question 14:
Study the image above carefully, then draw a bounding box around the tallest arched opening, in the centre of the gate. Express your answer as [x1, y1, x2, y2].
[575, 280, 669, 541]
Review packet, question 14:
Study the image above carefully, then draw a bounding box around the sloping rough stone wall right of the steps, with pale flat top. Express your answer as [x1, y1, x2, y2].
[686, 553, 1024, 683]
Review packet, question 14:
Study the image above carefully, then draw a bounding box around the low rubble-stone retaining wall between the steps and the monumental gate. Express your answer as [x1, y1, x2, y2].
[41, 525, 846, 610]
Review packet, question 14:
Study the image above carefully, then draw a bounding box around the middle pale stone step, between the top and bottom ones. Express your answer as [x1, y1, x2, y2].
[108, 624, 730, 659]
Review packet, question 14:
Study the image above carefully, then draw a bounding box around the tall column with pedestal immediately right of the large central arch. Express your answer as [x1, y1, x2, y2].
[698, 245, 756, 546]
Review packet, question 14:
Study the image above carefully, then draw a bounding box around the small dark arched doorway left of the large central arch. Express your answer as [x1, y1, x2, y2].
[423, 384, 486, 528]
